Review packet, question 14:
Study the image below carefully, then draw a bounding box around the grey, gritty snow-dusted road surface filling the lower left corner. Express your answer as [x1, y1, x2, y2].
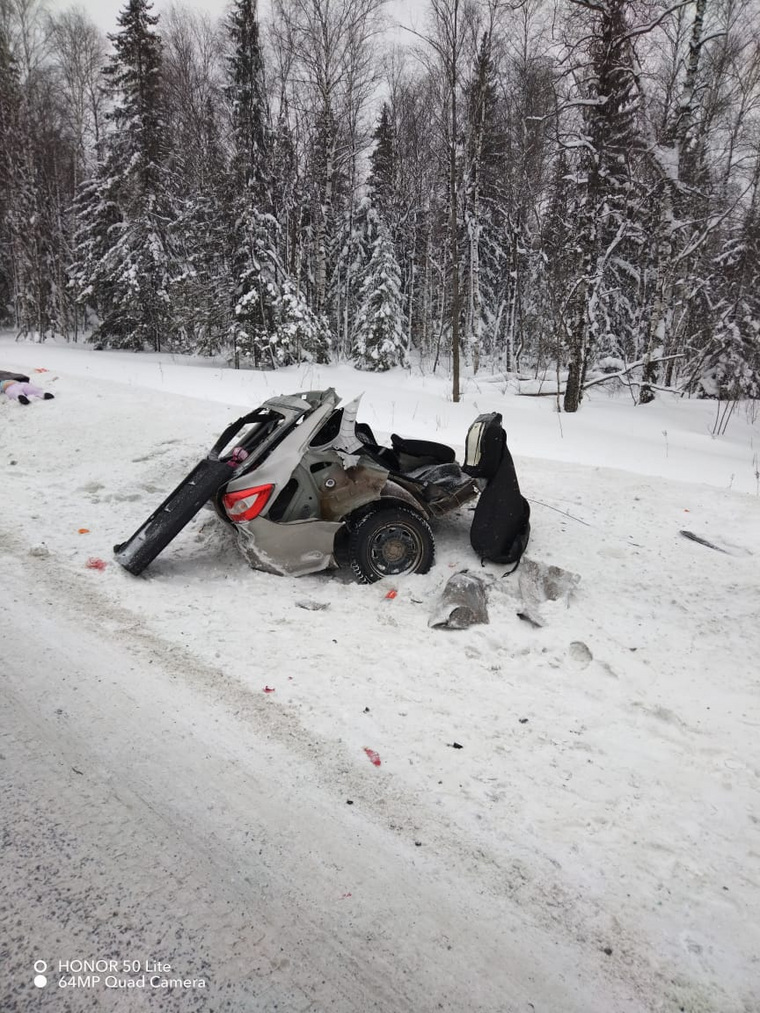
[0, 556, 656, 1013]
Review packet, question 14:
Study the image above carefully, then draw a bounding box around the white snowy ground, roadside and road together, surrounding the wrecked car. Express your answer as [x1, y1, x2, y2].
[0, 335, 760, 1013]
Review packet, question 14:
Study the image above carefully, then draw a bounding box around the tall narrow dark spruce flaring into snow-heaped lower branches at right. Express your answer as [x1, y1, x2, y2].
[226, 0, 330, 369]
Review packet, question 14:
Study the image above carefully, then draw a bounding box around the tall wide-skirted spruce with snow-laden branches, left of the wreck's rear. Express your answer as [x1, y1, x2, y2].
[73, 0, 180, 350]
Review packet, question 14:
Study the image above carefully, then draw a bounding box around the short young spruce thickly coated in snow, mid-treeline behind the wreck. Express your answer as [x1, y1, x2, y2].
[353, 209, 406, 372]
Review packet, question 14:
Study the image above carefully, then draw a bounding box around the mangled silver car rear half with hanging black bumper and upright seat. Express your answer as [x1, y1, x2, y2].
[113, 388, 530, 583]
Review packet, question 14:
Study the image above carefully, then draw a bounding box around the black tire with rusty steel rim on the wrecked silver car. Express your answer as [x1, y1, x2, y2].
[349, 507, 436, 583]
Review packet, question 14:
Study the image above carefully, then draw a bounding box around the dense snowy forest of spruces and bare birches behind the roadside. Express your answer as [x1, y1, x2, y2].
[0, 0, 760, 411]
